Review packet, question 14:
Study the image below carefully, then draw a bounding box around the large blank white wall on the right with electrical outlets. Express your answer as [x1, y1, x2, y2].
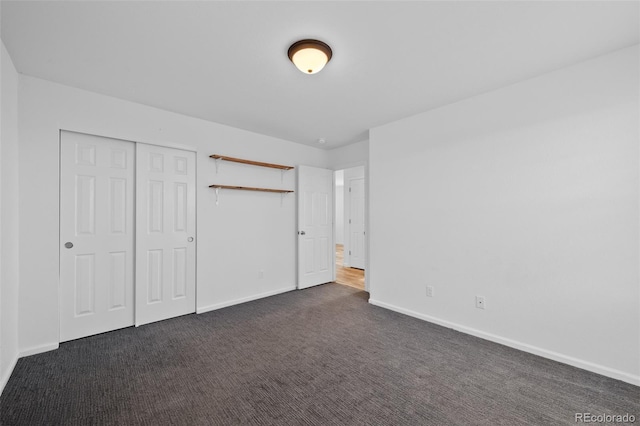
[369, 46, 640, 384]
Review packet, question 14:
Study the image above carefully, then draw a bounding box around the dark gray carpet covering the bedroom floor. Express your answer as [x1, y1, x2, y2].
[0, 284, 640, 426]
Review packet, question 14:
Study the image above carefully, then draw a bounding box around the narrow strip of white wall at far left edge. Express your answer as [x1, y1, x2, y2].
[0, 43, 19, 392]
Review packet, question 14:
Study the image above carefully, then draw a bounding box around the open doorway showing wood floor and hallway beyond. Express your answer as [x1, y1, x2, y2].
[334, 166, 367, 290]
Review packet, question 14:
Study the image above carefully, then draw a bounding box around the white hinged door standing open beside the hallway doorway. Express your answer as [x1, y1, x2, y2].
[298, 166, 334, 289]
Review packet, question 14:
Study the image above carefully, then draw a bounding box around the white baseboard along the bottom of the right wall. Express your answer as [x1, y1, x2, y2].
[369, 299, 640, 386]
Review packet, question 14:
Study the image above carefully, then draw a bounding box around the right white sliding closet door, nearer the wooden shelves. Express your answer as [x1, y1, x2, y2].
[136, 144, 196, 325]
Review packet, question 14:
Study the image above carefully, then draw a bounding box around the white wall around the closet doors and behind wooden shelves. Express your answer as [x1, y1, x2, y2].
[19, 76, 328, 355]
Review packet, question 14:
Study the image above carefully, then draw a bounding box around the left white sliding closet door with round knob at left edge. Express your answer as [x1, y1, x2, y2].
[60, 132, 135, 342]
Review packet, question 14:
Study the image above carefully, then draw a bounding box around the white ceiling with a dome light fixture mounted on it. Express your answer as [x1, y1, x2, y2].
[1, 1, 640, 148]
